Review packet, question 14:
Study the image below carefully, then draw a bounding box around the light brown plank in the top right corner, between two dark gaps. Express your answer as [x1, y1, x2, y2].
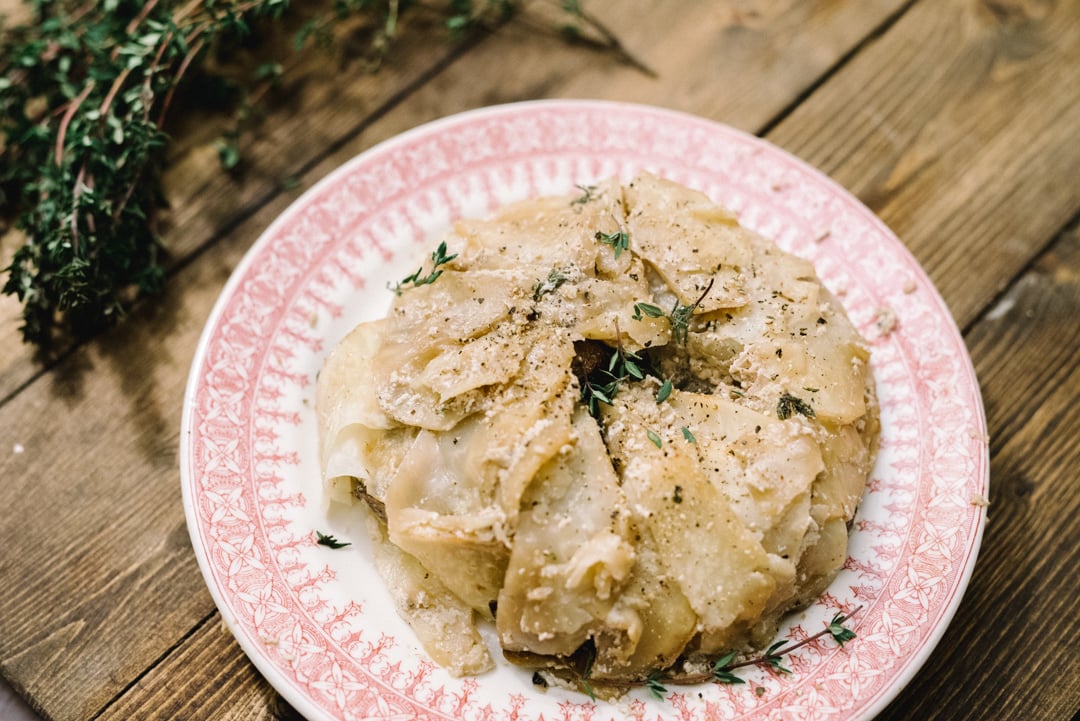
[769, 0, 1080, 327]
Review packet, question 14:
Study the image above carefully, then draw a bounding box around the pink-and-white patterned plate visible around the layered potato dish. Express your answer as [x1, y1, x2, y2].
[180, 100, 988, 721]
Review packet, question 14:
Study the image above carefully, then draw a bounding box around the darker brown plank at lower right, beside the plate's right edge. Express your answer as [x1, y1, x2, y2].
[881, 222, 1080, 721]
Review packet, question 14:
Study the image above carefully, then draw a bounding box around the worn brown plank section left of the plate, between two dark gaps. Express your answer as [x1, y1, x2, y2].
[0, 198, 274, 721]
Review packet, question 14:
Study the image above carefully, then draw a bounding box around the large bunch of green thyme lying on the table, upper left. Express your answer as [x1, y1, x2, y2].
[0, 0, 642, 345]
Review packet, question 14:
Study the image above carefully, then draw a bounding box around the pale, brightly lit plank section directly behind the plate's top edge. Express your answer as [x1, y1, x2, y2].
[464, 0, 906, 132]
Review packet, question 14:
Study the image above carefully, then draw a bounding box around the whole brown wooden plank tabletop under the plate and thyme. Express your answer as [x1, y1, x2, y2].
[0, 0, 1080, 721]
